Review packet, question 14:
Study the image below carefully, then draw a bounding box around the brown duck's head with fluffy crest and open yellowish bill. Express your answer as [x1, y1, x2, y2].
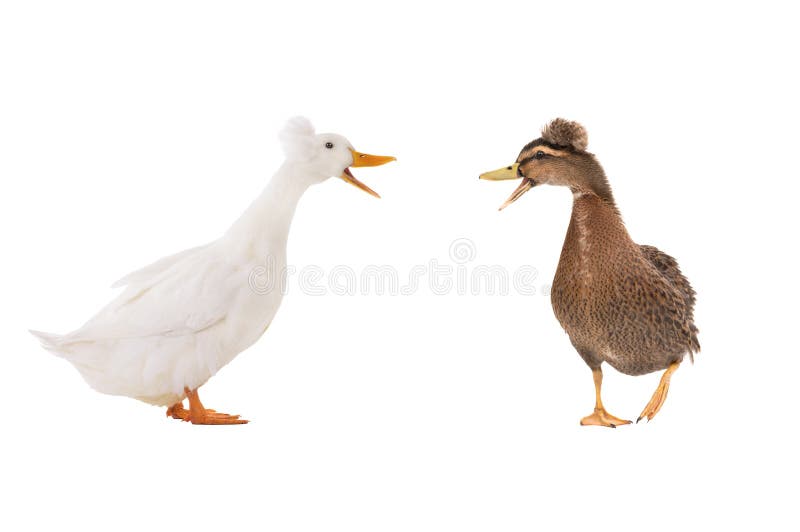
[480, 118, 614, 210]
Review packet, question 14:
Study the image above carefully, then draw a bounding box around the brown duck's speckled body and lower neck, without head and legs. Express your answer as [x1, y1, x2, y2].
[551, 193, 700, 375]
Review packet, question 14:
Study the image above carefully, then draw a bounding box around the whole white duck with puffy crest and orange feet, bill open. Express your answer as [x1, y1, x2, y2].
[31, 117, 395, 425]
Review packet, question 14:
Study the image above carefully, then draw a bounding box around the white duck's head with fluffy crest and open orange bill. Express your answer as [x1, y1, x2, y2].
[279, 116, 396, 198]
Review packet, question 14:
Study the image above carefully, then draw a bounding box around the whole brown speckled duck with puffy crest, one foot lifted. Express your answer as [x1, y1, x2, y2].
[481, 118, 700, 427]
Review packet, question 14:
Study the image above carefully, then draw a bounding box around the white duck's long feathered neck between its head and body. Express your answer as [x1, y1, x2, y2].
[225, 161, 318, 260]
